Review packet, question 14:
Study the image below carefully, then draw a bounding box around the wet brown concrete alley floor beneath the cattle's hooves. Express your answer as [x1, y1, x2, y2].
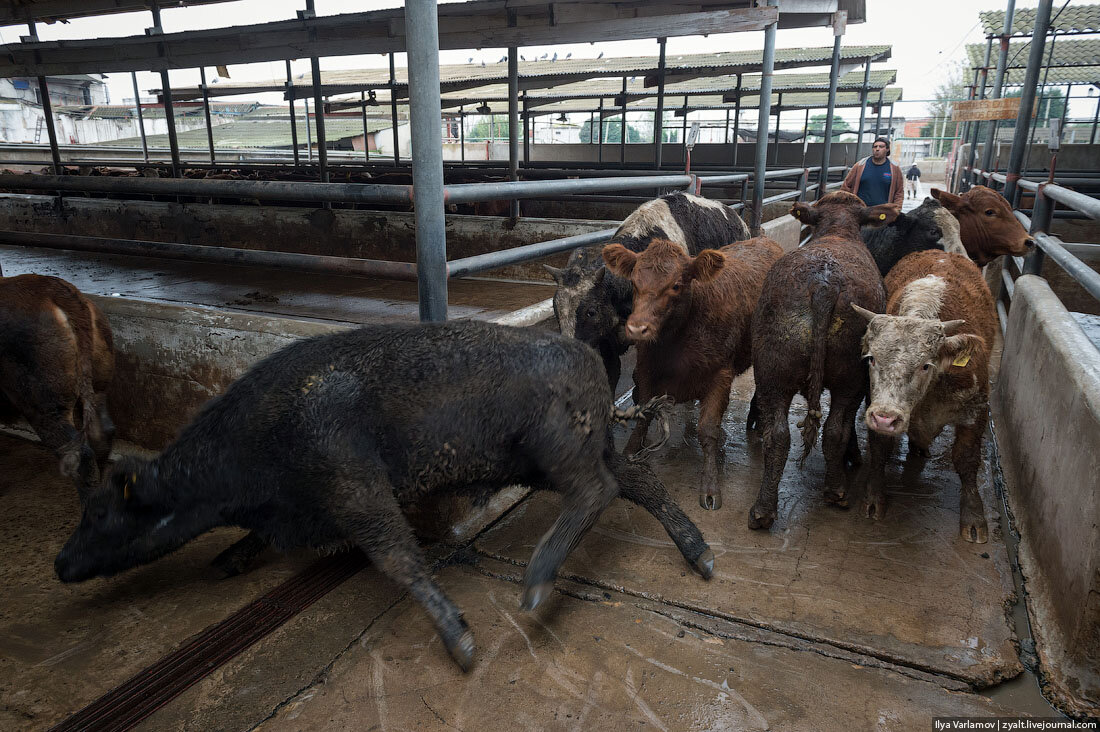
[0, 367, 1053, 732]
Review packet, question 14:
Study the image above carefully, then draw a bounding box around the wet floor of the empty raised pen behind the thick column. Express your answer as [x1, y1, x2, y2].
[0, 247, 553, 323]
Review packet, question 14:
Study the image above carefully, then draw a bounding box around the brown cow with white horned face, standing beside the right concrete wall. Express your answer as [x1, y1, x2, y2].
[854, 251, 997, 544]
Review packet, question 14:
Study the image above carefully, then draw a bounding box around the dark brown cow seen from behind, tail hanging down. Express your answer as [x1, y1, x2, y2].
[749, 190, 898, 528]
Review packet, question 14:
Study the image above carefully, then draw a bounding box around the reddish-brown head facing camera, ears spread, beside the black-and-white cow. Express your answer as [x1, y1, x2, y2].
[604, 239, 726, 342]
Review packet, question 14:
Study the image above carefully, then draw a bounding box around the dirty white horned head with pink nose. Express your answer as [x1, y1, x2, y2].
[851, 303, 985, 437]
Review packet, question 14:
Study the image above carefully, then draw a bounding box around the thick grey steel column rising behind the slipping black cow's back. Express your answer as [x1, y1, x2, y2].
[405, 0, 447, 320]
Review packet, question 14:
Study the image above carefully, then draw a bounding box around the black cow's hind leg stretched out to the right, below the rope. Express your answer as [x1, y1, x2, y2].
[607, 452, 714, 579]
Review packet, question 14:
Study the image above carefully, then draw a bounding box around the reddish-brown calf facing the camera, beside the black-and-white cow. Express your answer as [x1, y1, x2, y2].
[604, 237, 783, 510]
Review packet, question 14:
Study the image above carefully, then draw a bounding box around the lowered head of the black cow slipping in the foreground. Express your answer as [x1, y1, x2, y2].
[54, 458, 198, 582]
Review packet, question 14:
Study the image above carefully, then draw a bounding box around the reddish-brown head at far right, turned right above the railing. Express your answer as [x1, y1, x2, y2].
[932, 186, 1035, 266]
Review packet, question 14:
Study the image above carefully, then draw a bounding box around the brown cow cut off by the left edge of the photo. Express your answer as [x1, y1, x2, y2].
[0, 274, 114, 499]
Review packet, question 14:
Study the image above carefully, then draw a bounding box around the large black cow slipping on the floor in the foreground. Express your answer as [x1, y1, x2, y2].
[55, 321, 714, 669]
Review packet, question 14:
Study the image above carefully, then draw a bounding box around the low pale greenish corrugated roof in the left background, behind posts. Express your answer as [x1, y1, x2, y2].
[99, 117, 392, 150]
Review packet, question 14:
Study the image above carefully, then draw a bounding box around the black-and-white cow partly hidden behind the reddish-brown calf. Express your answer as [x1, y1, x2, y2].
[547, 193, 749, 389]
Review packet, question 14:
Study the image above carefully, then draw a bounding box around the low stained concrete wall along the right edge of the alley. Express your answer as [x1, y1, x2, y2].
[993, 276, 1100, 714]
